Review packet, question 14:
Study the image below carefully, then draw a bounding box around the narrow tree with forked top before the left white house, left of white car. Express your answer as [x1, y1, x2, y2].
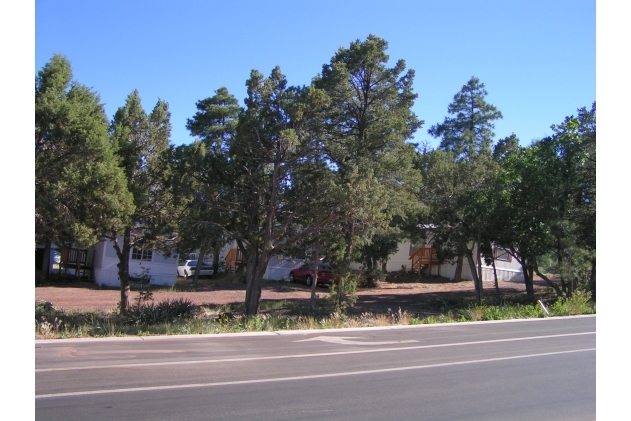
[107, 90, 174, 314]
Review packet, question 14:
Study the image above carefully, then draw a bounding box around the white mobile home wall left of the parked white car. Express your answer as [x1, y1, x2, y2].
[94, 238, 177, 287]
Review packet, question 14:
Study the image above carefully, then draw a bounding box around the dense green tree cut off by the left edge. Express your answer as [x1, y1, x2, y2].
[35, 54, 134, 277]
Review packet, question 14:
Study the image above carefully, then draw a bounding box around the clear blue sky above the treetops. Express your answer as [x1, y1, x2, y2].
[34, 0, 596, 146]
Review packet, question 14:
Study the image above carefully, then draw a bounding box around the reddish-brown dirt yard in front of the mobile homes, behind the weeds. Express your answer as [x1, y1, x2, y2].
[35, 276, 545, 315]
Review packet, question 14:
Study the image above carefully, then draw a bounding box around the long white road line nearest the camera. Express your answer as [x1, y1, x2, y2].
[35, 348, 596, 399]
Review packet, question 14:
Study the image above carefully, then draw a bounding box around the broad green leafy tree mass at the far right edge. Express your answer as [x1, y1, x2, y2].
[496, 105, 596, 296]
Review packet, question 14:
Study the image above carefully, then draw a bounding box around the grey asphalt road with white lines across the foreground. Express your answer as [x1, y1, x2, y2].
[35, 316, 596, 421]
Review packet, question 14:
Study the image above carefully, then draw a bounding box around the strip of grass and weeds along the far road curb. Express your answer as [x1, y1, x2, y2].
[35, 285, 596, 339]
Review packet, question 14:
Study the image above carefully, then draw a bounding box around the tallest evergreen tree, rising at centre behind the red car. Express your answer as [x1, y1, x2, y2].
[314, 35, 423, 264]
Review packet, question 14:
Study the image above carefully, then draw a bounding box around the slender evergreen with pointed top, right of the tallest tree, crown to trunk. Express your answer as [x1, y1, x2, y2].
[421, 77, 504, 302]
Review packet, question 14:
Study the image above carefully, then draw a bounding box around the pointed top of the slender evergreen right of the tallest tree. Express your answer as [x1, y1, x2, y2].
[429, 76, 502, 159]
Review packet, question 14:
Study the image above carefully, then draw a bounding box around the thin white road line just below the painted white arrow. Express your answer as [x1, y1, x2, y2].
[35, 332, 596, 373]
